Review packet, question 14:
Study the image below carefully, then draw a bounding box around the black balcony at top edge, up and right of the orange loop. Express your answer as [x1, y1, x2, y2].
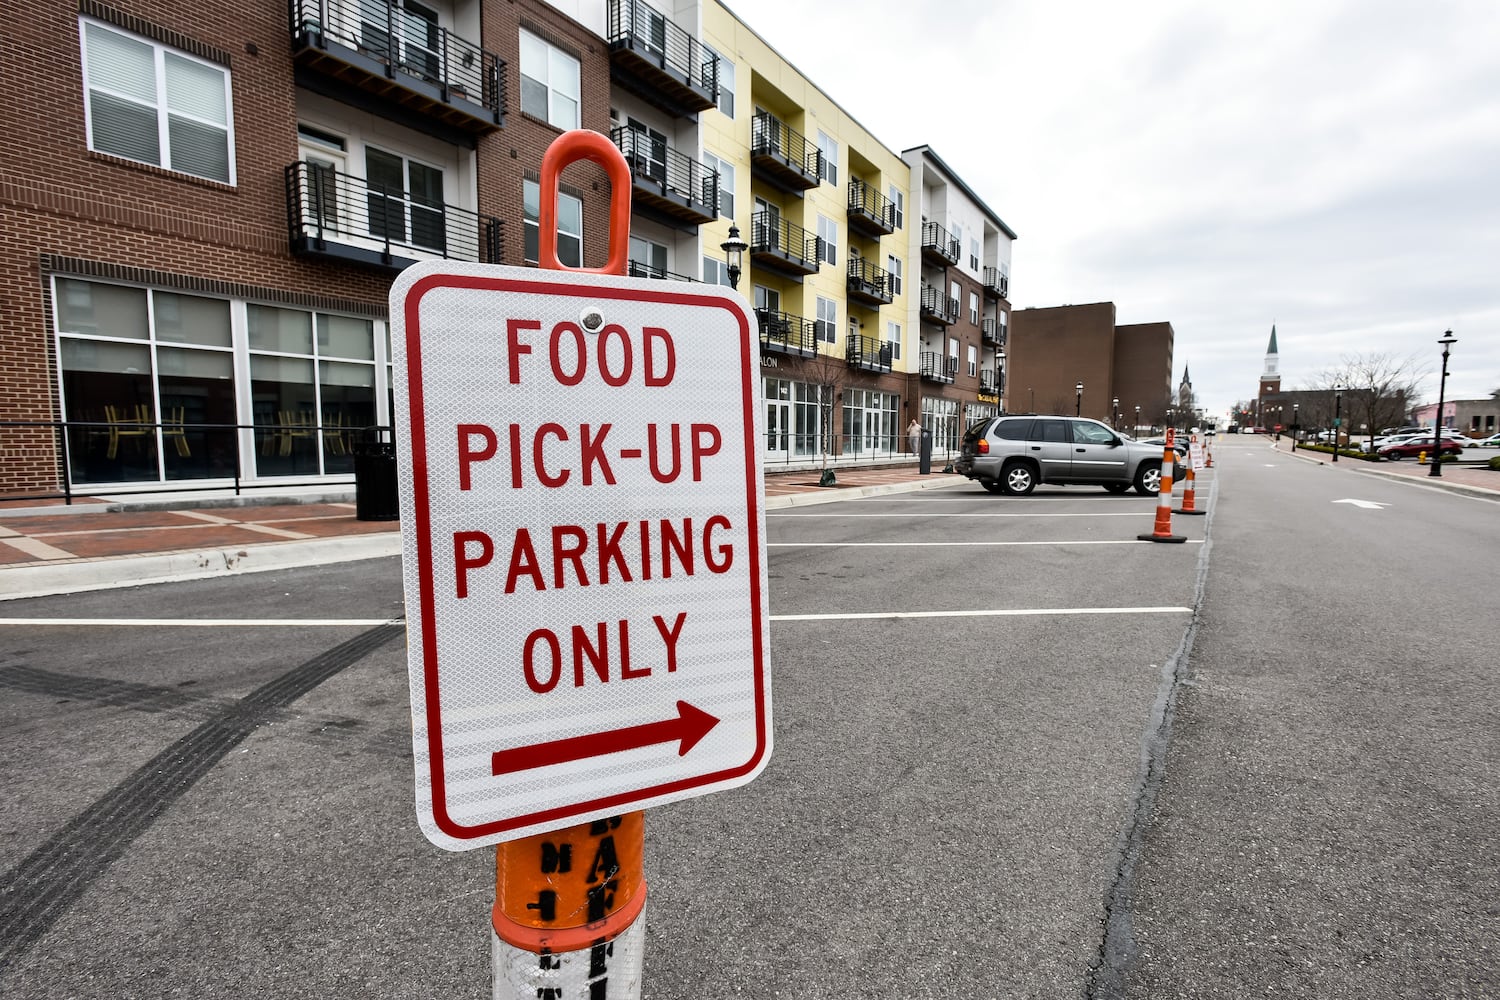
[606, 0, 719, 118]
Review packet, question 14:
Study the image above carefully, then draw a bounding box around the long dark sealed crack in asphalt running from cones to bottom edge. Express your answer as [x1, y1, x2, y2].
[1085, 475, 1218, 1000]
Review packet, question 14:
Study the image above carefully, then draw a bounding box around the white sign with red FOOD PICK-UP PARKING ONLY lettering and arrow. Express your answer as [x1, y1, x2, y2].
[392, 261, 771, 850]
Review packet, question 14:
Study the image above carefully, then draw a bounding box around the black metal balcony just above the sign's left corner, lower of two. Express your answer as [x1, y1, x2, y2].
[285, 162, 503, 270]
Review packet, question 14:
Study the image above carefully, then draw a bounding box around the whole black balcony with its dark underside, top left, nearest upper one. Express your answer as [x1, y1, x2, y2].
[290, 0, 506, 145]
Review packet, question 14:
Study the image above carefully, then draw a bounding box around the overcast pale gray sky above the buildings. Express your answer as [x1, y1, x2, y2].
[729, 0, 1500, 412]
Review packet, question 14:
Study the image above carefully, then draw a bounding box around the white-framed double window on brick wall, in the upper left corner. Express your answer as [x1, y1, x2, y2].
[80, 19, 234, 184]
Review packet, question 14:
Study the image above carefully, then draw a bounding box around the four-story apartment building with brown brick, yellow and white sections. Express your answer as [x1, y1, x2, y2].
[0, 0, 1014, 495]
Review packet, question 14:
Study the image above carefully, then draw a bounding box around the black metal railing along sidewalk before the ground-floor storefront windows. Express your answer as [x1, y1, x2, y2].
[0, 411, 405, 504]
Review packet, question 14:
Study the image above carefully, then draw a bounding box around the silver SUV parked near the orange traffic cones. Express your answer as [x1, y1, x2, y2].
[953, 414, 1178, 496]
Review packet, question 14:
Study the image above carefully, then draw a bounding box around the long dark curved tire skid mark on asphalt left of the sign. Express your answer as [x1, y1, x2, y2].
[0, 625, 405, 976]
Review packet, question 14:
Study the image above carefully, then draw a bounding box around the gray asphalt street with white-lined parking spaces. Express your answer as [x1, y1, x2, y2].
[0, 436, 1500, 1000]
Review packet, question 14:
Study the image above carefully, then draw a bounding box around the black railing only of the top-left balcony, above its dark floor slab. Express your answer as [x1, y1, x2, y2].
[291, 0, 506, 115]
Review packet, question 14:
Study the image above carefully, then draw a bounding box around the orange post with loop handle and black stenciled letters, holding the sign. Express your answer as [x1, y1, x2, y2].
[491, 129, 647, 1000]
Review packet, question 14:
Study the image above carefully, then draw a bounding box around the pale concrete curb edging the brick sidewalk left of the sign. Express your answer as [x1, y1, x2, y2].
[0, 531, 401, 601]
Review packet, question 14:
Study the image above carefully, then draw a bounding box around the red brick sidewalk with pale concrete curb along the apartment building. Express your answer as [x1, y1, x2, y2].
[0, 465, 965, 601]
